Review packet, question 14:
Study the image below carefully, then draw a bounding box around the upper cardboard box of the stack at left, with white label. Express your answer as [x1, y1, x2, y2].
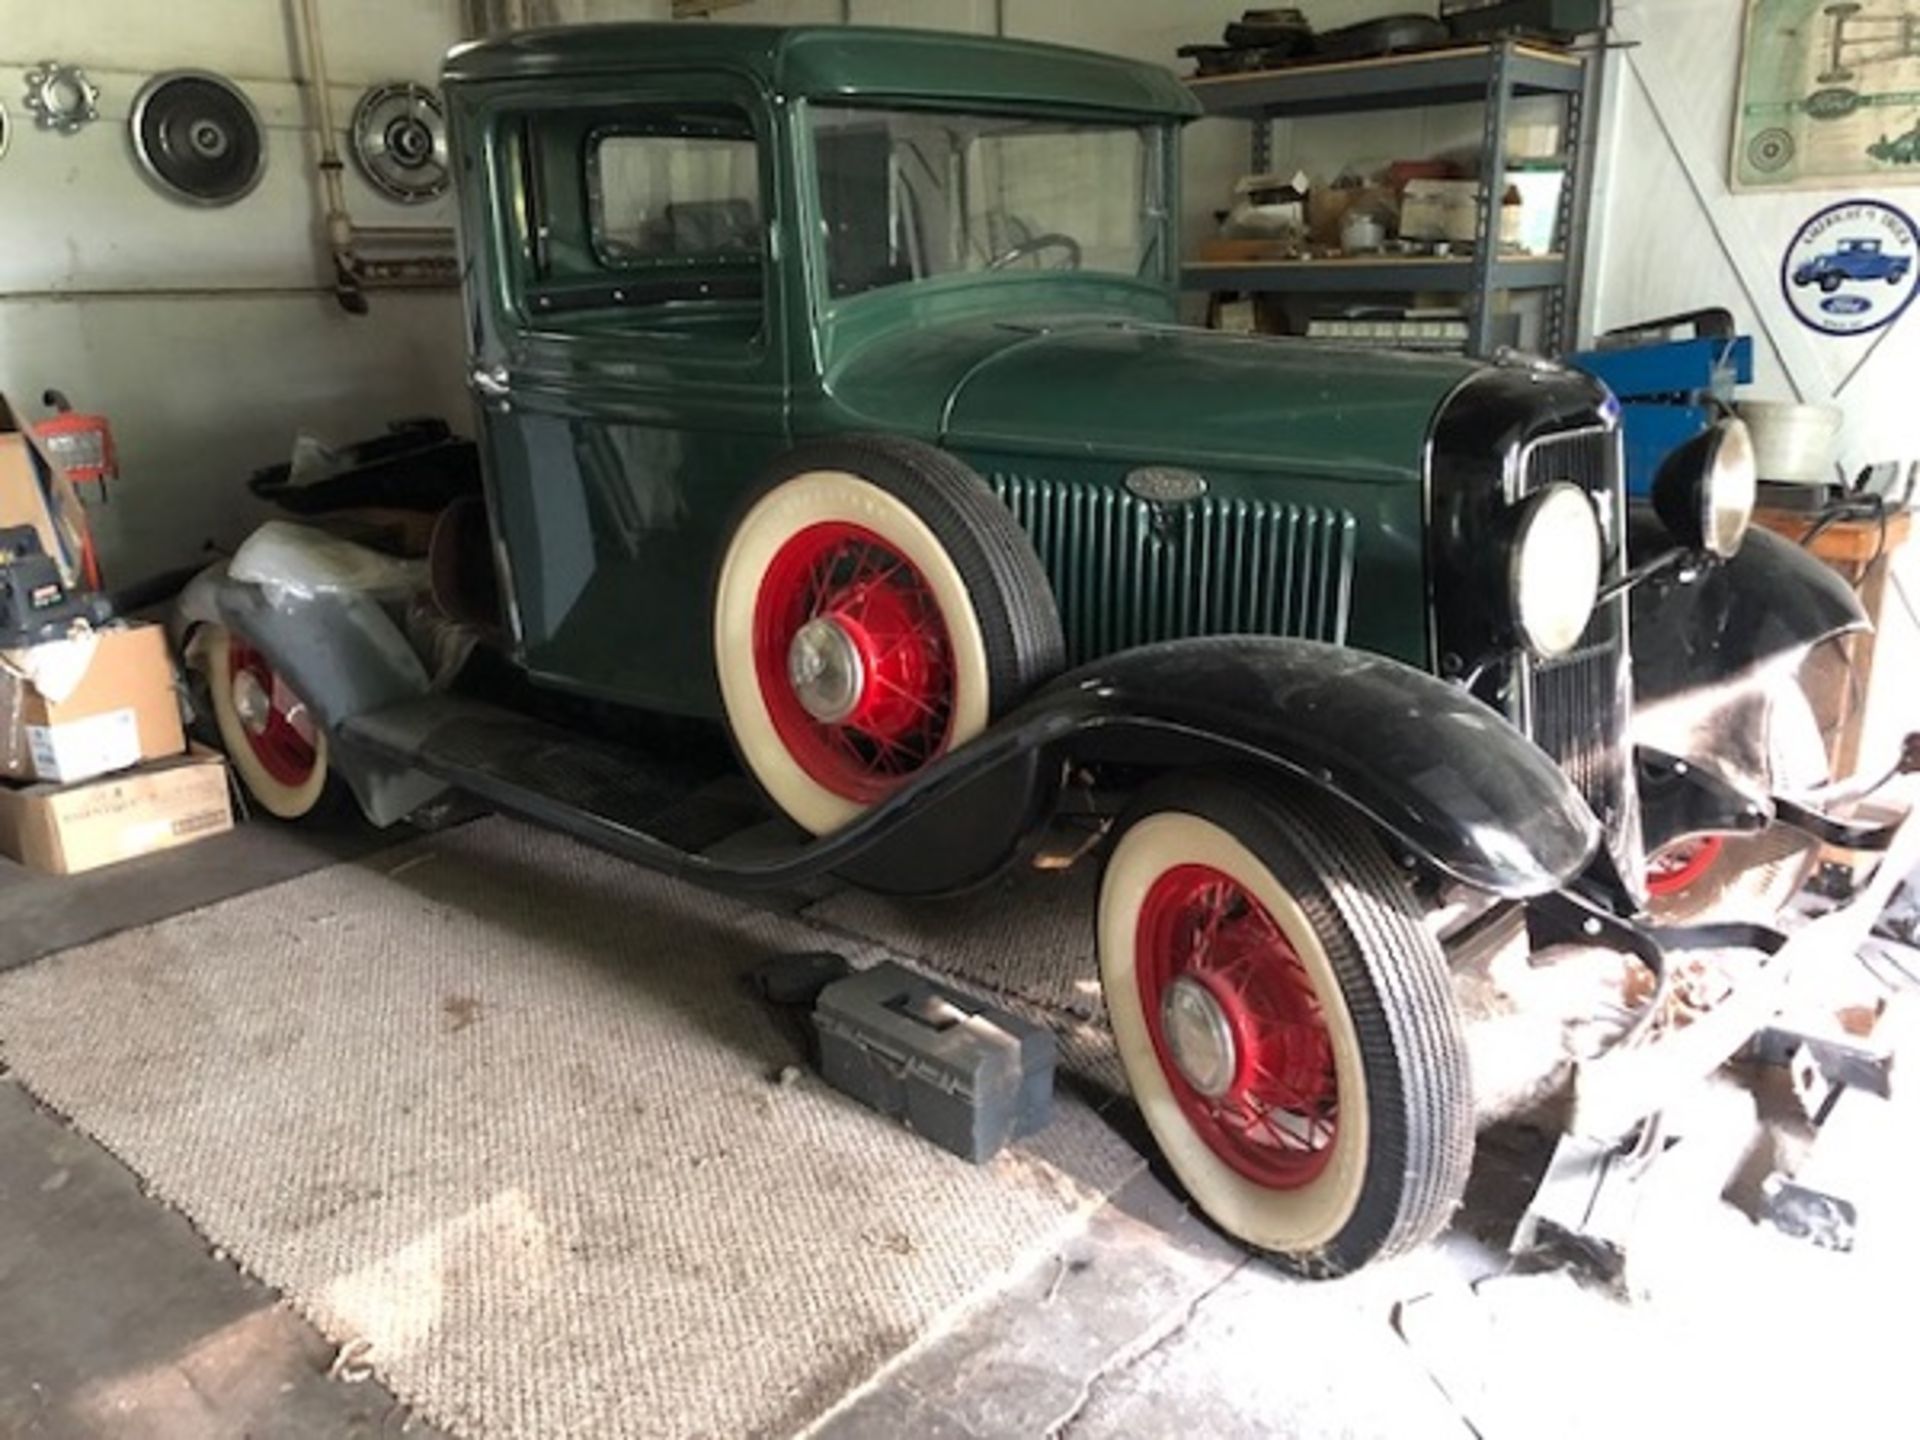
[0, 624, 186, 783]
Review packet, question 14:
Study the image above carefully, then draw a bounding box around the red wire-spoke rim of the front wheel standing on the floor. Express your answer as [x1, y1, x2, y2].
[1137, 864, 1340, 1190]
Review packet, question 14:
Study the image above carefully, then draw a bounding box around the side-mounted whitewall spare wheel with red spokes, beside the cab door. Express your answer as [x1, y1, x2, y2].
[714, 436, 1066, 835]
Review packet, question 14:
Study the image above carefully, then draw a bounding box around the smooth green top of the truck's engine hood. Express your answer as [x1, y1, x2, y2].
[829, 319, 1475, 482]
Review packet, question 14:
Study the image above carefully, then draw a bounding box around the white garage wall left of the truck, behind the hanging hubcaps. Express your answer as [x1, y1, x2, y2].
[0, 0, 478, 584]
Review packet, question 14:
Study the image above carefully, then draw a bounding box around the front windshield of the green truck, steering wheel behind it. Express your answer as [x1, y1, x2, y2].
[812, 106, 1165, 296]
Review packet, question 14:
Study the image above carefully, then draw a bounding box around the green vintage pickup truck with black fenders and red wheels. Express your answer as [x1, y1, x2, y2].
[180, 25, 1887, 1275]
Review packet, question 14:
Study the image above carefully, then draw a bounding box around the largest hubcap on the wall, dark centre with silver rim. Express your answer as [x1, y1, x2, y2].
[129, 69, 267, 205]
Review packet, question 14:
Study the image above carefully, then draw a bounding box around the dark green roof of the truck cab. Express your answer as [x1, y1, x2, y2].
[442, 21, 1200, 119]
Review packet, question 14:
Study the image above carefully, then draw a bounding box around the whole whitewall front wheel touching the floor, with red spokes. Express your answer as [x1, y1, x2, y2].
[1098, 776, 1475, 1279]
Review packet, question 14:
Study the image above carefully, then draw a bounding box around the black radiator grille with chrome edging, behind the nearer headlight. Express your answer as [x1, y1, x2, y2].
[1523, 430, 1640, 862]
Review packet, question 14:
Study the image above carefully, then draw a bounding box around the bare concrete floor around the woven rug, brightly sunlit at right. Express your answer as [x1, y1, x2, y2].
[0, 822, 1920, 1440]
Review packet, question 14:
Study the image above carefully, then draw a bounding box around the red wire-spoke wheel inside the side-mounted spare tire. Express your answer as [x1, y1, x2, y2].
[753, 520, 954, 804]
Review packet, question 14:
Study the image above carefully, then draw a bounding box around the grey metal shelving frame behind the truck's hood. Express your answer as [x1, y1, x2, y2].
[1181, 40, 1588, 353]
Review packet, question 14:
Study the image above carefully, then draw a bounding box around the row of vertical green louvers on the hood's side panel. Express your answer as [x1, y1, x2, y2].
[989, 474, 1354, 664]
